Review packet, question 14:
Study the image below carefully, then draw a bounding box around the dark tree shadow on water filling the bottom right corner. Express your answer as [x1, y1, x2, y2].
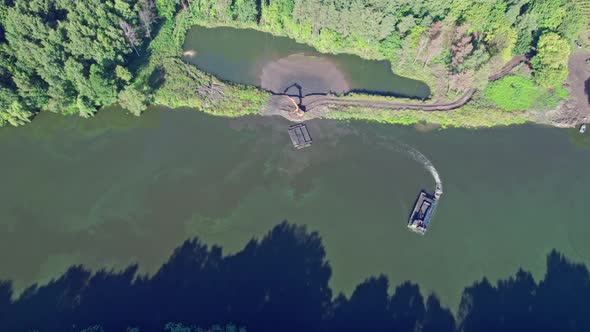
[459, 251, 590, 332]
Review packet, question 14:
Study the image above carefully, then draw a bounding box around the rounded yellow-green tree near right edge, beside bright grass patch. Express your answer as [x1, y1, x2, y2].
[531, 32, 571, 87]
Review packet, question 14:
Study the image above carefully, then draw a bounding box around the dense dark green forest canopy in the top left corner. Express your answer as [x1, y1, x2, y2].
[0, 0, 155, 123]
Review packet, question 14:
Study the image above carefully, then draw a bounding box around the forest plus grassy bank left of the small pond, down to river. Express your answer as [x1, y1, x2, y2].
[0, 0, 266, 126]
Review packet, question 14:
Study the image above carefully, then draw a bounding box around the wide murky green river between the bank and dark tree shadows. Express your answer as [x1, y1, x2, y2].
[0, 109, 590, 308]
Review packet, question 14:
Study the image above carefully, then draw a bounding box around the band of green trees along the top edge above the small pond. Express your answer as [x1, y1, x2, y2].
[184, 0, 585, 71]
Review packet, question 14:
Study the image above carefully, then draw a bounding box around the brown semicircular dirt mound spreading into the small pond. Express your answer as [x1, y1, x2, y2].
[260, 54, 350, 96]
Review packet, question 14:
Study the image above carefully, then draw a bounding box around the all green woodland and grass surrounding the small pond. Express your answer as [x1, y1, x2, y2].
[0, 0, 587, 125]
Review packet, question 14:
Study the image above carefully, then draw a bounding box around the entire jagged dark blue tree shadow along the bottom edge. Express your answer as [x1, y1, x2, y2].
[0, 222, 590, 332]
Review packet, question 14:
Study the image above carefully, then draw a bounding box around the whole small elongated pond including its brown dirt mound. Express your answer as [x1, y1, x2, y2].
[184, 26, 430, 99]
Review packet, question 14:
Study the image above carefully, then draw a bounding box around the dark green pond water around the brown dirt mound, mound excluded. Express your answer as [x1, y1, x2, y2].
[184, 26, 430, 99]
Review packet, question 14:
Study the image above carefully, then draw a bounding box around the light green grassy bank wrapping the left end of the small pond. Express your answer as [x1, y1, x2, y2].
[134, 8, 270, 117]
